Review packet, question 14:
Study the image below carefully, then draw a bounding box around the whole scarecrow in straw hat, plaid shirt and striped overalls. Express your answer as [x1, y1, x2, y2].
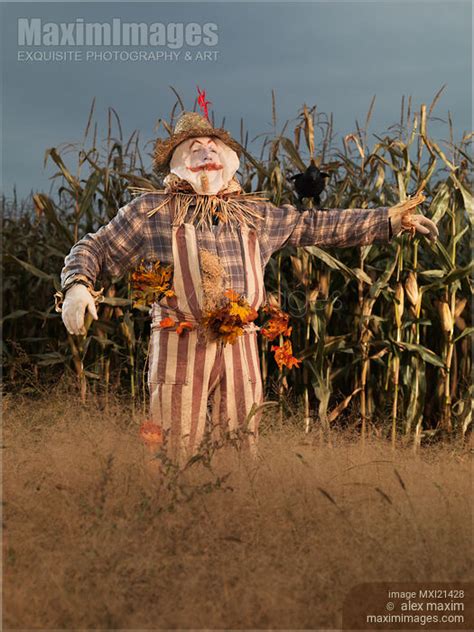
[57, 97, 438, 458]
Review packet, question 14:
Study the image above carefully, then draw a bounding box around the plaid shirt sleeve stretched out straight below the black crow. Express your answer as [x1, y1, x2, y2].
[260, 202, 390, 258]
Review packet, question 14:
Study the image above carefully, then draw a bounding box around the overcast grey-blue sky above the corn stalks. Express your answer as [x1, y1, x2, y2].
[2, 0, 472, 196]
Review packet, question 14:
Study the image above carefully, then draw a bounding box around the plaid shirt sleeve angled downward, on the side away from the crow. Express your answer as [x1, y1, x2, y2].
[61, 198, 147, 288]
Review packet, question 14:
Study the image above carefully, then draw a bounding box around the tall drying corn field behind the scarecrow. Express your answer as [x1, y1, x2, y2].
[2, 89, 474, 449]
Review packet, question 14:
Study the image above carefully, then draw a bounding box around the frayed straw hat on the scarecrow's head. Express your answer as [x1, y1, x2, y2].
[153, 112, 242, 172]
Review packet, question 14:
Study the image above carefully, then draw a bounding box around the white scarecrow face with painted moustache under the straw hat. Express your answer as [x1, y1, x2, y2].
[170, 136, 239, 195]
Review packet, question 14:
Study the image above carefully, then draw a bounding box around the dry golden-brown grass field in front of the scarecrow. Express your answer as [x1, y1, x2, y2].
[2, 393, 472, 630]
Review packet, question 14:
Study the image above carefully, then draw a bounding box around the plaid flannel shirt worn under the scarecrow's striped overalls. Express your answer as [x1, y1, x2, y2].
[61, 193, 391, 293]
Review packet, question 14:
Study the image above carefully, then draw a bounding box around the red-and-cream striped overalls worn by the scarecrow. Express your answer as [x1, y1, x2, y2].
[148, 223, 265, 458]
